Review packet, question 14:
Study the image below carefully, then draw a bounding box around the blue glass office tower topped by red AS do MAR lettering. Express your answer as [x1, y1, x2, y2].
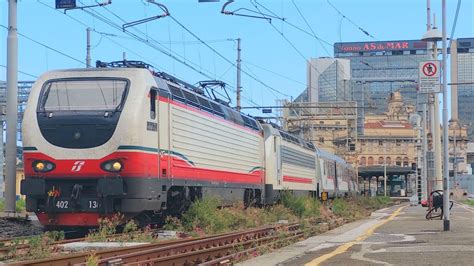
[334, 41, 429, 114]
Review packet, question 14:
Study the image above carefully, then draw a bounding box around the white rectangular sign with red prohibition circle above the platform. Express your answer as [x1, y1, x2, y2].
[418, 60, 441, 93]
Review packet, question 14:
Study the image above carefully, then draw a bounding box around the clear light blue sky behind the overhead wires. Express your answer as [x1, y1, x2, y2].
[0, 0, 474, 117]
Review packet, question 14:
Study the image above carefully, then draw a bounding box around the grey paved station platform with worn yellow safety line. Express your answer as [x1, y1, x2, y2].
[241, 203, 474, 266]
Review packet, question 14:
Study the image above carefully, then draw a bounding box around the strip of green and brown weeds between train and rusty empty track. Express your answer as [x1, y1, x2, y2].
[165, 193, 392, 235]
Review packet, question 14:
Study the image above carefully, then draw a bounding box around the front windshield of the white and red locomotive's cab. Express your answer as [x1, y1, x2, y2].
[40, 79, 128, 112]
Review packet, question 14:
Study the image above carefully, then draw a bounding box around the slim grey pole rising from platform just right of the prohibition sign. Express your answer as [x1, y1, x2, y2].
[441, 0, 450, 231]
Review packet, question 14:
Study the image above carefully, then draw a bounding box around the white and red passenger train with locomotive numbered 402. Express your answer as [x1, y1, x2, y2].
[21, 61, 357, 227]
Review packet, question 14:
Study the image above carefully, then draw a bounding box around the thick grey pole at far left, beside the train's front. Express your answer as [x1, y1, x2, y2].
[5, 0, 18, 213]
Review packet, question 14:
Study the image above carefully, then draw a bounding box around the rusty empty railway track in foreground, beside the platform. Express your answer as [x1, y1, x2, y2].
[12, 224, 305, 266]
